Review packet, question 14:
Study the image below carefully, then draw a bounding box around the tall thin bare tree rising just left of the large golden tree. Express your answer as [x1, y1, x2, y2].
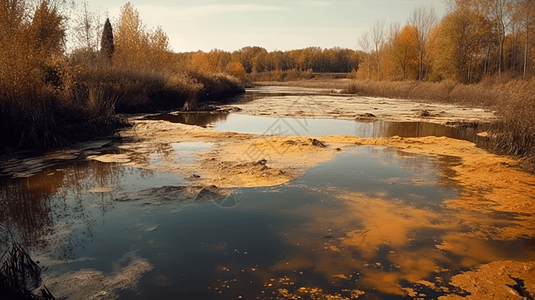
[409, 6, 437, 80]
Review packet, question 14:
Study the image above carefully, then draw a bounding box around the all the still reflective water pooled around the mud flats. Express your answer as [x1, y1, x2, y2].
[0, 88, 535, 300]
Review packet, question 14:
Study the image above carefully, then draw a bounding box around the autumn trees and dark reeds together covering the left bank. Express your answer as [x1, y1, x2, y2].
[0, 0, 243, 151]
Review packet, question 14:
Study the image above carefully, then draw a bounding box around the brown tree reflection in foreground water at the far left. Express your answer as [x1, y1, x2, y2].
[0, 161, 124, 259]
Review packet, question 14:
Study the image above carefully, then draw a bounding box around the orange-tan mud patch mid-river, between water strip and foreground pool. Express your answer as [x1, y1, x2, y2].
[88, 120, 344, 188]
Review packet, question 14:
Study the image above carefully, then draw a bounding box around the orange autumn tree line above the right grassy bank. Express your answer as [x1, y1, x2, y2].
[357, 0, 535, 83]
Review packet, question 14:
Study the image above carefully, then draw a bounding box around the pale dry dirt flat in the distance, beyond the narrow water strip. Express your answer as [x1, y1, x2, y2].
[222, 86, 497, 124]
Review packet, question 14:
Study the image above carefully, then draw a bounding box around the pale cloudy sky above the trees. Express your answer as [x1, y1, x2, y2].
[82, 0, 445, 52]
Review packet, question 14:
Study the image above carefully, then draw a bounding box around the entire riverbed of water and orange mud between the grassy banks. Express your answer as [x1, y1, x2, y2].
[0, 87, 535, 299]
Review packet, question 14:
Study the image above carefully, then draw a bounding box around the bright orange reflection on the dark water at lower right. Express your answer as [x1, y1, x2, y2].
[246, 152, 535, 299]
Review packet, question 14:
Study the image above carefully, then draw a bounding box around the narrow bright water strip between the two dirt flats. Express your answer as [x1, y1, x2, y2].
[148, 113, 485, 143]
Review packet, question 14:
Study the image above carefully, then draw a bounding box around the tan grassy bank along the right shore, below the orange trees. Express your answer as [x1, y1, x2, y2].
[343, 77, 535, 170]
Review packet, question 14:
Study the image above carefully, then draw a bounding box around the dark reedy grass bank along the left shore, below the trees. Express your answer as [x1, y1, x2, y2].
[0, 68, 243, 152]
